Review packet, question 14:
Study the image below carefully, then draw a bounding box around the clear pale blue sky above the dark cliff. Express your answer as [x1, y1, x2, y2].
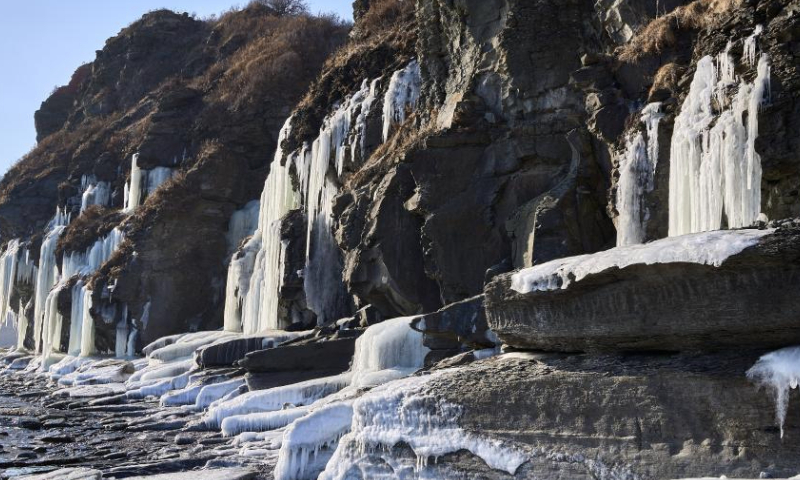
[0, 0, 352, 173]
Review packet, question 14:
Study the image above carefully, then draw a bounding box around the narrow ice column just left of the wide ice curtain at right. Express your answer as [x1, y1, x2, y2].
[616, 103, 664, 247]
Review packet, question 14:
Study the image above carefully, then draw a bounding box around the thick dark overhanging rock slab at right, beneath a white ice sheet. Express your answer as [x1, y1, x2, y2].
[485, 227, 800, 352]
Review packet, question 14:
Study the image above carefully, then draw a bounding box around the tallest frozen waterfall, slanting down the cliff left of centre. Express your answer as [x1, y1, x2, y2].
[225, 61, 421, 334]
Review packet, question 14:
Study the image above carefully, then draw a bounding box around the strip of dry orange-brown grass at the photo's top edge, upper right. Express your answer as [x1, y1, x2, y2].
[619, 0, 741, 62]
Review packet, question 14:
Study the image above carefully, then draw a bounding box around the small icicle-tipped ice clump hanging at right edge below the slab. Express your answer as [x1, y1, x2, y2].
[747, 347, 800, 438]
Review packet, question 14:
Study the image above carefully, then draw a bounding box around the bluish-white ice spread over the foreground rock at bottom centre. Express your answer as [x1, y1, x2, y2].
[319, 371, 527, 480]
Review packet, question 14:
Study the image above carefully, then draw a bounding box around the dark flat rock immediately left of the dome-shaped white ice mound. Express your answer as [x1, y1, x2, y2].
[239, 338, 355, 373]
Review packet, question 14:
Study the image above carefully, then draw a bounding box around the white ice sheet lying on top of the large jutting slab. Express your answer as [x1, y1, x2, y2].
[511, 229, 774, 293]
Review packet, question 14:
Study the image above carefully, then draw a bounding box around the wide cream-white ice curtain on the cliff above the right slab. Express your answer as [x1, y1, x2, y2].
[669, 41, 770, 236]
